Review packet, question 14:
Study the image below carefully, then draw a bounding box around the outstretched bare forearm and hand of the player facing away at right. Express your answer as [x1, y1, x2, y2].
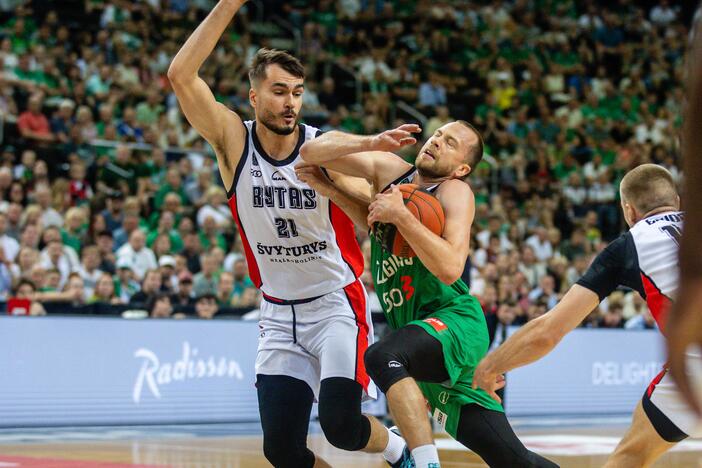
[473, 284, 600, 401]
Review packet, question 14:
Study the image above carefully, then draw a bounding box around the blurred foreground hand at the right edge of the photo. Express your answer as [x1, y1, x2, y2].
[665, 280, 702, 416]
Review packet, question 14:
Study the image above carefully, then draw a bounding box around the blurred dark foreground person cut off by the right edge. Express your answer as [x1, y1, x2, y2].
[667, 0, 702, 421]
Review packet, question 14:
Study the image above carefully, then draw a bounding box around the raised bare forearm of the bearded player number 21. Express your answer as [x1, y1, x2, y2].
[168, 0, 247, 82]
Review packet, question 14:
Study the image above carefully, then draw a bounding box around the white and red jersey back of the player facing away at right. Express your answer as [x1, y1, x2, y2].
[630, 211, 684, 326]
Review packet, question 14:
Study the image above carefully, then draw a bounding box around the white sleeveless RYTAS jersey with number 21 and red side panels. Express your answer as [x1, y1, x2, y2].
[228, 121, 363, 300]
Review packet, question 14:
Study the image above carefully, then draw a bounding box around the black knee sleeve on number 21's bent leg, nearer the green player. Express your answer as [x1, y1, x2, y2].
[319, 377, 370, 451]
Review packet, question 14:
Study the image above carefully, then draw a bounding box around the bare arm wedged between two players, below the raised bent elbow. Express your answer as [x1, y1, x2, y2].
[295, 163, 370, 229]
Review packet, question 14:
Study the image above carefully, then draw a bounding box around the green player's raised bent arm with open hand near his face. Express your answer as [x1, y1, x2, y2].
[300, 124, 422, 190]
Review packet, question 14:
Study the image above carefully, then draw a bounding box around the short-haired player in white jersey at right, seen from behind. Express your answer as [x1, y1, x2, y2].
[473, 164, 702, 468]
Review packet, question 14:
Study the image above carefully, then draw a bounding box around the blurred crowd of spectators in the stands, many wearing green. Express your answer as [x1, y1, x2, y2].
[0, 0, 691, 334]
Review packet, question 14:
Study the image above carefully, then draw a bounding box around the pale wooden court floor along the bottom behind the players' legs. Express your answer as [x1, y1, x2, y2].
[0, 428, 702, 468]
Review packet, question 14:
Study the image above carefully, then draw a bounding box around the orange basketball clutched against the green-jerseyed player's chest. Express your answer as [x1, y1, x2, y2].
[373, 184, 444, 257]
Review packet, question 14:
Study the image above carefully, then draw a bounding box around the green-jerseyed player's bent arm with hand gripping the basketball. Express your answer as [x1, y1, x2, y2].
[368, 180, 475, 284]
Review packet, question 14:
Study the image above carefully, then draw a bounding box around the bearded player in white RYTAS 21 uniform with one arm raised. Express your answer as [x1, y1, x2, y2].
[168, 0, 409, 468]
